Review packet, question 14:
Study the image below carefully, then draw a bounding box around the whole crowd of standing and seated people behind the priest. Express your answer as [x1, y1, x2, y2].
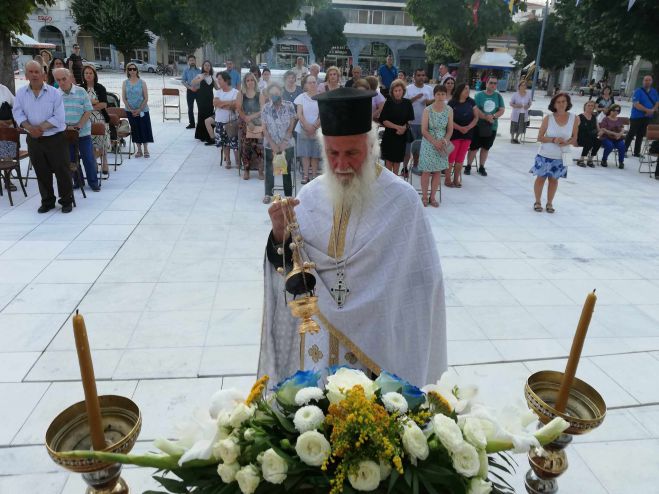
[0, 49, 659, 213]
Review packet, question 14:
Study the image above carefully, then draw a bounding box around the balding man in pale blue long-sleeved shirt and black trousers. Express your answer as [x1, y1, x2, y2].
[12, 60, 73, 213]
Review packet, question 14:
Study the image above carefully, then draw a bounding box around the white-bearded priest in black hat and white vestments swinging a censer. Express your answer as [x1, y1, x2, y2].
[258, 88, 447, 385]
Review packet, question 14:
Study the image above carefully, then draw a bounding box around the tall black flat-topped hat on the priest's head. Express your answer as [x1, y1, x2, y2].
[312, 87, 375, 136]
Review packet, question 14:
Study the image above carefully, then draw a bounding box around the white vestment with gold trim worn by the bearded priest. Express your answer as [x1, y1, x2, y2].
[258, 165, 447, 385]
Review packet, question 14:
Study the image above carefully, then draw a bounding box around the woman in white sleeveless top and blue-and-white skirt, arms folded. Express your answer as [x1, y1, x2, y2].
[529, 93, 579, 213]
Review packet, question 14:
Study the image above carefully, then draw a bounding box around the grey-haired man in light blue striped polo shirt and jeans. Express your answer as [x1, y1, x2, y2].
[53, 69, 101, 192]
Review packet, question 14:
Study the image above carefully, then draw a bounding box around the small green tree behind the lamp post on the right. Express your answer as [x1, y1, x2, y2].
[517, 13, 583, 90]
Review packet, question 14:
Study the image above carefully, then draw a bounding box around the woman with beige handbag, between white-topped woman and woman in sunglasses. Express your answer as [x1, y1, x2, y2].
[238, 72, 265, 180]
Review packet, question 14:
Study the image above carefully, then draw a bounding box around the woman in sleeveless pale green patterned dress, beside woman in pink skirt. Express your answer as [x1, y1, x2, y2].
[419, 85, 453, 208]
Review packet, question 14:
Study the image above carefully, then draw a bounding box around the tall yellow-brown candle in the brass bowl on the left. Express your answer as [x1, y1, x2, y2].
[73, 310, 106, 451]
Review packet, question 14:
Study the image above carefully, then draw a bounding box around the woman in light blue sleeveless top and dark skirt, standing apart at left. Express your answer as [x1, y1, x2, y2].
[121, 63, 153, 158]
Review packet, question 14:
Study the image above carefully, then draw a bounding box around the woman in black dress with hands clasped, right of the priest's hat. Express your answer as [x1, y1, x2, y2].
[380, 79, 416, 175]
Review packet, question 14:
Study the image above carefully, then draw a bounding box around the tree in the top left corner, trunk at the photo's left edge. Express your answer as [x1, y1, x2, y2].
[0, 0, 54, 93]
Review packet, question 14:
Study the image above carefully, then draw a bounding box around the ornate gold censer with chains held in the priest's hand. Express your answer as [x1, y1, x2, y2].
[273, 195, 320, 370]
